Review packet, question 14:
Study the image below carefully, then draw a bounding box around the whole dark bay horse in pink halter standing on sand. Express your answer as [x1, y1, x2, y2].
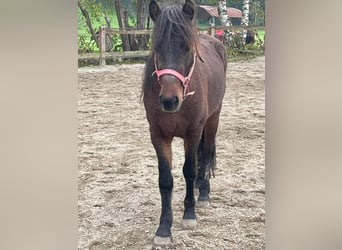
[142, 0, 227, 245]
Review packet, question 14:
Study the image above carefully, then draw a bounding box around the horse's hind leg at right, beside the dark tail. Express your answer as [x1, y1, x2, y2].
[196, 112, 218, 207]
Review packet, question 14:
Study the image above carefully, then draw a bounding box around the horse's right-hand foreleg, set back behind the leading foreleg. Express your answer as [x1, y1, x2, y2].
[182, 135, 200, 228]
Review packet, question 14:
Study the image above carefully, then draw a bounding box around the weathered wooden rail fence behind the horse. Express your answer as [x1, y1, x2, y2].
[78, 26, 265, 65]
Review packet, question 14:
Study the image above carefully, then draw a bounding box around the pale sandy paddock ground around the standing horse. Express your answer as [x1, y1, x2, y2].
[78, 57, 265, 250]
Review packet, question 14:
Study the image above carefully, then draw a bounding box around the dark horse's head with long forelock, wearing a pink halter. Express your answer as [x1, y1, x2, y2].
[149, 0, 197, 112]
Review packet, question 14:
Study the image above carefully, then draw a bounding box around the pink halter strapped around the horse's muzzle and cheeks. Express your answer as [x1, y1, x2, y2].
[152, 53, 196, 99]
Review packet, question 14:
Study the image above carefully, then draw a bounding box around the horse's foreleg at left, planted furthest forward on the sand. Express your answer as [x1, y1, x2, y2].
[151, 136, 173, 245]
